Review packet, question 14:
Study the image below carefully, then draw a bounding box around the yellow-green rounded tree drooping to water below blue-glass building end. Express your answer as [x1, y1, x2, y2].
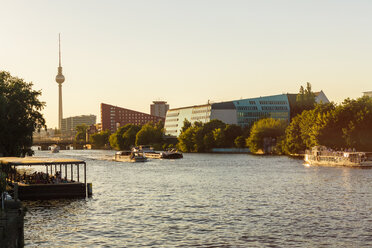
[246, 118, 287, 152]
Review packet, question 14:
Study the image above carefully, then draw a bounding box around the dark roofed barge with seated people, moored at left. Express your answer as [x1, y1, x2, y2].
[0, 157, 92, 200]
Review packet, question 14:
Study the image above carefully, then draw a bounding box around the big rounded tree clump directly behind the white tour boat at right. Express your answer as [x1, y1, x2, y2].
[278, 96, 372, 154]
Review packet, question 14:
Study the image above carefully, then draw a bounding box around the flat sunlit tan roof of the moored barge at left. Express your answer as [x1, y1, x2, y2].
[0, 157, 85, 165]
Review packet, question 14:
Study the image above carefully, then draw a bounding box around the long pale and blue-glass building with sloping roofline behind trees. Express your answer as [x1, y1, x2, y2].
[164, 91, 329, 136]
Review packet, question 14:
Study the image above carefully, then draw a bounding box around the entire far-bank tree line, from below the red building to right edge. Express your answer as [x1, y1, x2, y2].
[91, 83, 372, 157]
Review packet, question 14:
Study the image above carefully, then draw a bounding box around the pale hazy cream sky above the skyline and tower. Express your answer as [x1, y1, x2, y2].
[0, 0, 372, 128]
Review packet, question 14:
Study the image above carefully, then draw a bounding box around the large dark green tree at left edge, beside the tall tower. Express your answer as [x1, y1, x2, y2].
[0, 71, 46, 156]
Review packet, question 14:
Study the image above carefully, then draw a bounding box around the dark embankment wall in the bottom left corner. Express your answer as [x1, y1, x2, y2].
[0, 200, 25, 248]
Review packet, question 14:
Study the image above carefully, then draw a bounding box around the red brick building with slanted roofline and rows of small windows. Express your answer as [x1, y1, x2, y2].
[101, 103, 165, 132]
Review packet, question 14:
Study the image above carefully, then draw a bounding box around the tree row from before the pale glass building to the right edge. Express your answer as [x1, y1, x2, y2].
[177, 83, 372, 155]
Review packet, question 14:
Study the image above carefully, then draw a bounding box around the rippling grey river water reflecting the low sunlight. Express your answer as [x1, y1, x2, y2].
[25, 150, 372, 247]
